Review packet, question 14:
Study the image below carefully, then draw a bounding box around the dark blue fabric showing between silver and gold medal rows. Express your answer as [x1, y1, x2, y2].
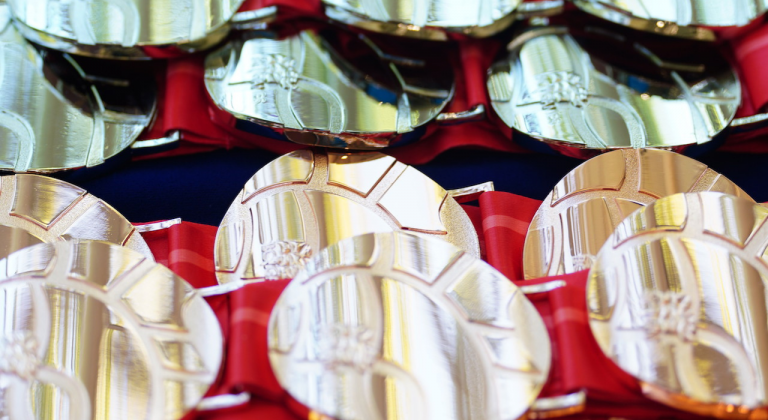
[59, 150, 768, 226]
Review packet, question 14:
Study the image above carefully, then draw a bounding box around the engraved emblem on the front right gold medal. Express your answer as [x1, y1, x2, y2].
[645, 290, 698, 343]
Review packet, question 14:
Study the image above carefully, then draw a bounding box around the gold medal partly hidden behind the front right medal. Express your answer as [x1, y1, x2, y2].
[523, 149, 752, 279]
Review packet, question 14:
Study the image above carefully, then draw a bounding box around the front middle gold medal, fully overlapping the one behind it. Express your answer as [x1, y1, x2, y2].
[268, 232, 551, 420]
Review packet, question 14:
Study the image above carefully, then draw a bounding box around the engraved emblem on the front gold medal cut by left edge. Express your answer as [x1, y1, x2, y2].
[0, 331, 42, 381]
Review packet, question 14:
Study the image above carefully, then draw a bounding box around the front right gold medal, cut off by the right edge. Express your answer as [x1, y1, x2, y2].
[587, 192, 768, 418]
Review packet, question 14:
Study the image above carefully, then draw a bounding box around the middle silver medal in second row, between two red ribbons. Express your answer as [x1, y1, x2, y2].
[205, 31, 453, 149]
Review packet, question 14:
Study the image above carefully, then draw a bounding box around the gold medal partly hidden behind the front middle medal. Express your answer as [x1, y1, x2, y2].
[214, 150, 480, 284]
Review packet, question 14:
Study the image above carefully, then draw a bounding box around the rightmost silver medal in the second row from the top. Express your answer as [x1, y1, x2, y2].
[488, 27, 741, 151]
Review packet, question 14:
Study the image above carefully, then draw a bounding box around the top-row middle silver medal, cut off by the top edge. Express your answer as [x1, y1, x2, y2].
[323, 0, 522, 41]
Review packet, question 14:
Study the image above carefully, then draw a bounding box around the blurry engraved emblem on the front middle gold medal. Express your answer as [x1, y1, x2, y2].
[318, 324, 378, 371]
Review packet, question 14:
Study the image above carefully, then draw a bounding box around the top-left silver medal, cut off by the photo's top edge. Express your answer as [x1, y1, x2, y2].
[7, 0, 243, 59]
